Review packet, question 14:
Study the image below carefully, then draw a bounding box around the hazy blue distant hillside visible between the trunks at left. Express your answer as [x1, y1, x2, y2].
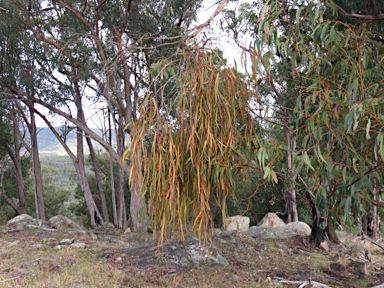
[31, 127, 115, 157]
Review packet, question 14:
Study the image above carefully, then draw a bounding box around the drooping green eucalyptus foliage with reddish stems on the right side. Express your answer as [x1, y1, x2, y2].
[249, 1, 384, 243]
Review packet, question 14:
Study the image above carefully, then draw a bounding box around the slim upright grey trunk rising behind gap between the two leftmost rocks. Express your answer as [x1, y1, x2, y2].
[28, 101, 45, 220]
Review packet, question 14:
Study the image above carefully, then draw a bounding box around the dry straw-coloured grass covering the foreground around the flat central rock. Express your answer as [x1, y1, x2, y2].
[0, 233, 384, 288]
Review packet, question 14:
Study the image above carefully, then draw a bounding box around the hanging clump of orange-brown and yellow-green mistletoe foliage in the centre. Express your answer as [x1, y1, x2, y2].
[126, 50, 276, 243]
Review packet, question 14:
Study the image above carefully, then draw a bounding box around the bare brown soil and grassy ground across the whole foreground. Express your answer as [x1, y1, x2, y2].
[0, 231, 384, 288]
